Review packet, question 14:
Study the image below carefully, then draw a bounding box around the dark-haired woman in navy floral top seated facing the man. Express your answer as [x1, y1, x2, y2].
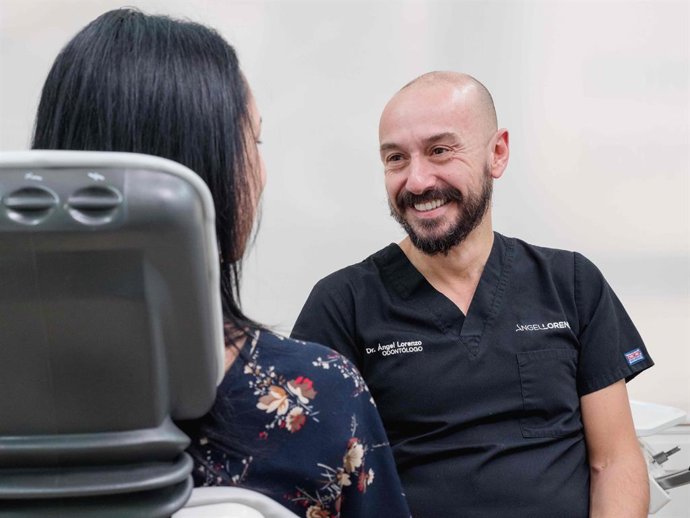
[33, 9, 409, 518]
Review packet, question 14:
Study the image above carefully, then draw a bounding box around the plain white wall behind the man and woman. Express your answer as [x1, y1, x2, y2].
[0, 0, 690, 411]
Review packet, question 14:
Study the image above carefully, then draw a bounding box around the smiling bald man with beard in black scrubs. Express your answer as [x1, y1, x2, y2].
[293, 72, 653, 518]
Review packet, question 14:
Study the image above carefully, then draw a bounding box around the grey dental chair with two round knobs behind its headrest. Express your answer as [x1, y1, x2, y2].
[0, 151, 295, 518]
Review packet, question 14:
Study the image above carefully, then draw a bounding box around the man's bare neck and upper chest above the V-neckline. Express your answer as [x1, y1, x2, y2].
[400, 217, 494, 314]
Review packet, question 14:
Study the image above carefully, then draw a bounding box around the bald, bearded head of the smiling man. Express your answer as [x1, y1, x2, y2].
[379, 72, 509, 255]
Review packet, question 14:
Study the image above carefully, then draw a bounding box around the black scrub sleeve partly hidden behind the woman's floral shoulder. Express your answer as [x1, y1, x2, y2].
[290, 279, 362, 370]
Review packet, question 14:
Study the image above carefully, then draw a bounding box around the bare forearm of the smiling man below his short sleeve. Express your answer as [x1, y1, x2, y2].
[580, 380, 649, 518]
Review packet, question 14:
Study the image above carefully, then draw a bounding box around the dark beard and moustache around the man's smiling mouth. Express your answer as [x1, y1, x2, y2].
[388, 165, 493, 256]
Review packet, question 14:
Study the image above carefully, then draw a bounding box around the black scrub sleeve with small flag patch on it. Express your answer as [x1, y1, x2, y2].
[574, 253, 654, 396]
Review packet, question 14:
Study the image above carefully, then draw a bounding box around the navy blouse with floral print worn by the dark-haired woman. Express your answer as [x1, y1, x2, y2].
[185, 331, 410, 518]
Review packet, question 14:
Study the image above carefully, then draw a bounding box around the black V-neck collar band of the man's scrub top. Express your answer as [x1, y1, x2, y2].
[373, 232, 515, 357]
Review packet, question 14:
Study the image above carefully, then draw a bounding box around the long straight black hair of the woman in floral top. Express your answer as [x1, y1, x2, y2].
[32, 9, 258, 341]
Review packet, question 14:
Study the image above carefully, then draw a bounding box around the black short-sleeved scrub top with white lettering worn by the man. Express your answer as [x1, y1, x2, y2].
[292, 233, 653, 518]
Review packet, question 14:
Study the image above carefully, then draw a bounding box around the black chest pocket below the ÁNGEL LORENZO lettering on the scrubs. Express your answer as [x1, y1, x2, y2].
[516, 349, 582, 438]
